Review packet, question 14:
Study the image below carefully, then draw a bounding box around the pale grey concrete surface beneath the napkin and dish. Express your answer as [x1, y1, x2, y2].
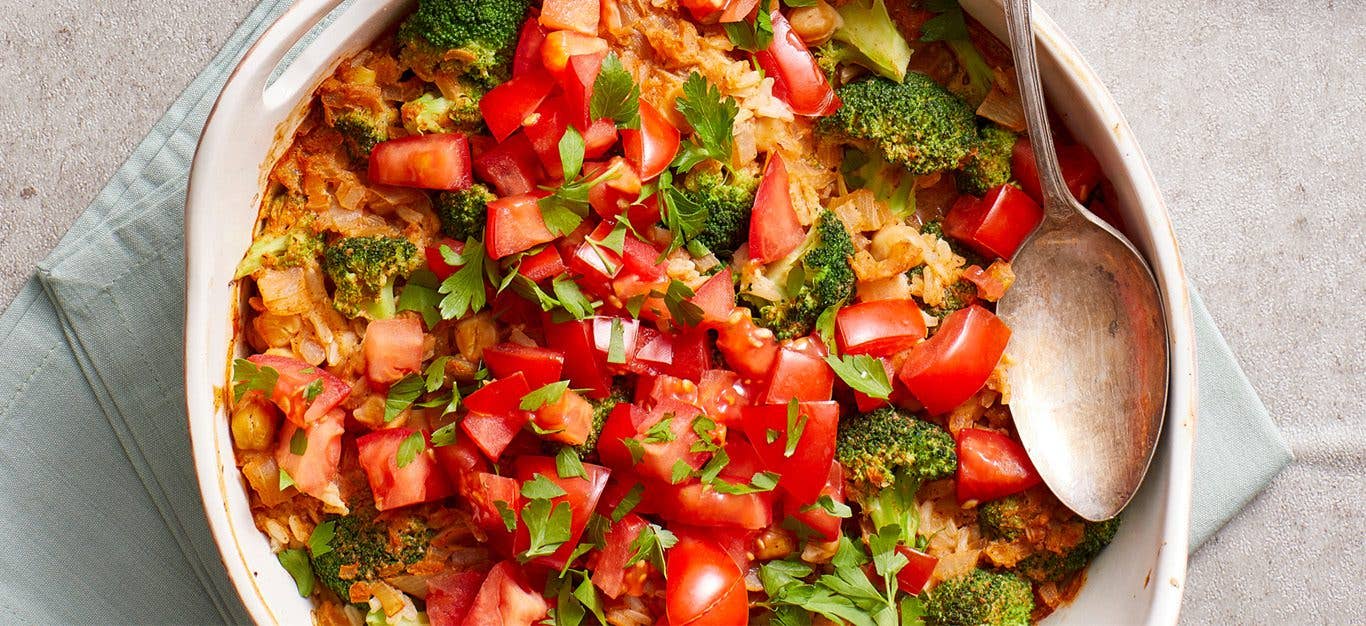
[0, 0, 1366, 623]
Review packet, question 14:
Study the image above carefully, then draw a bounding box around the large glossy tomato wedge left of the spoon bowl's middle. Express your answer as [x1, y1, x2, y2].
[897, 305, 1011, 416]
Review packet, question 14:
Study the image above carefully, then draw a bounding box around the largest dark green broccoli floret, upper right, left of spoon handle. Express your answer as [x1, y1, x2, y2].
[818, 72, 978, 175]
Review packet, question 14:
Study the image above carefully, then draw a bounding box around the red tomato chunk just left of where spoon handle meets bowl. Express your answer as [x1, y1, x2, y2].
[944, 185, 1044, 260]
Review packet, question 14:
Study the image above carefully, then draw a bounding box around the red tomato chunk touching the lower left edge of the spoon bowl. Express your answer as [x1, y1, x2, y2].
[956, 428, 1044, 504]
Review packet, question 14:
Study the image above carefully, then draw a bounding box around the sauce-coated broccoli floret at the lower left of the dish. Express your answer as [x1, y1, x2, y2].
[311, 511, 433, 601]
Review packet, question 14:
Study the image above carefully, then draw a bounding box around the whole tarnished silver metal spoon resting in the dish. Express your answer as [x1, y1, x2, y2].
[996, 0, 1168, 521]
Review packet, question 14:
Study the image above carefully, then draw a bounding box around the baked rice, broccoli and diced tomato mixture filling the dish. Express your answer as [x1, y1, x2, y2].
[227, 0, 1117, 626]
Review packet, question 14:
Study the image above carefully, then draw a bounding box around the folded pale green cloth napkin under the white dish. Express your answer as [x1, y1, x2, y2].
[0, 0, 1291, 623]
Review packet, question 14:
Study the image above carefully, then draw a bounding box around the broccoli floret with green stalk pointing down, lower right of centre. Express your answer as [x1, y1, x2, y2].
[835, 407, 958, 545]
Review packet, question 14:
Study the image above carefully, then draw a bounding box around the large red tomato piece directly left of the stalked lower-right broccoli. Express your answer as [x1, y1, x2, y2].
[740, 402, 840, 502]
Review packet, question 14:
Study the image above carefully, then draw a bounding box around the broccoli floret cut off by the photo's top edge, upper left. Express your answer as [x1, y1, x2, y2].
[398, 0, 530, 87]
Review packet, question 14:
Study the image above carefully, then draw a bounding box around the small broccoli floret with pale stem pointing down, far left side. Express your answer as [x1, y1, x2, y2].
[322, 236, 422, 320]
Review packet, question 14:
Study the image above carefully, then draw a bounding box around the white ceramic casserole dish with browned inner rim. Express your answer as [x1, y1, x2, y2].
[184, 0, 1195, 625]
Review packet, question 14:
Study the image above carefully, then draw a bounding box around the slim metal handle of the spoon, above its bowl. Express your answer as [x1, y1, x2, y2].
[1005, 0, 1076, 221]
